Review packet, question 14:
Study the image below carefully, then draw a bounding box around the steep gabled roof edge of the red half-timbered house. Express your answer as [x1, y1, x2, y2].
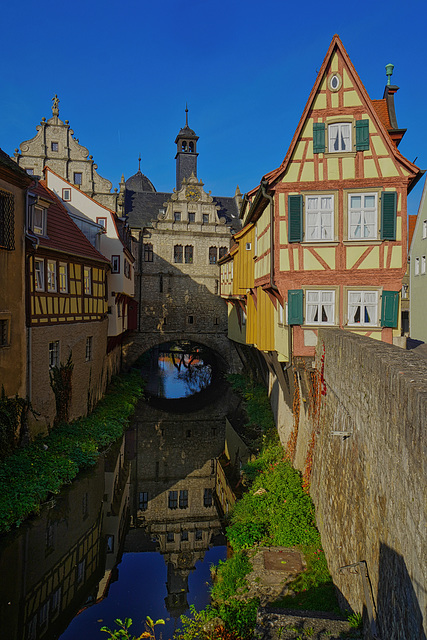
[264, 35, 422, 193]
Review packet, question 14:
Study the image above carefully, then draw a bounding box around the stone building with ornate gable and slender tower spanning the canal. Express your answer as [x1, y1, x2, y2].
[125, 112, 241, 364]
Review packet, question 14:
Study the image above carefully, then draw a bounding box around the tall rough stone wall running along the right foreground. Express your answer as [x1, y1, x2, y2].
[311, 329, 427, 640]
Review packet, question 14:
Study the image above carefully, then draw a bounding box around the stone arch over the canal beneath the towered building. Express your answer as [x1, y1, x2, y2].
[123, 331, 242, 373]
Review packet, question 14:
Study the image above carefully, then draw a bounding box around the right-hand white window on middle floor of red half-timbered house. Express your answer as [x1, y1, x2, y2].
[348, 193, 378, 240]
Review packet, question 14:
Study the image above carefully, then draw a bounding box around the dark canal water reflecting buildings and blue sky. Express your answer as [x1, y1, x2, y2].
[0, 348, 238, 640]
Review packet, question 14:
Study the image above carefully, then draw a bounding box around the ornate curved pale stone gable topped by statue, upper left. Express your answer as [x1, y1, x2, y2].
[15, 96, 120, 215]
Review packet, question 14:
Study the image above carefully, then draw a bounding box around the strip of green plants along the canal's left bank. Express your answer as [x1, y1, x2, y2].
[0, 371, 142, 532]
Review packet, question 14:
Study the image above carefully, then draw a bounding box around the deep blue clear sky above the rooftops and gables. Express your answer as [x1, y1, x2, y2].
[0, 0, 427, 213]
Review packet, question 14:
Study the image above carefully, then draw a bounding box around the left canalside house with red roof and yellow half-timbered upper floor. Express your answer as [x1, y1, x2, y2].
[26, 181, 110, 435]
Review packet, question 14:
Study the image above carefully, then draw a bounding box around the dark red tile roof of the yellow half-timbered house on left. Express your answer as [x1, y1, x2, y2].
[31, 180, 109, 263]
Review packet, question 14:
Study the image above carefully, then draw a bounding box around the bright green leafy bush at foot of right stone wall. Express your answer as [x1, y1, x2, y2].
[227, 442, 319, 550]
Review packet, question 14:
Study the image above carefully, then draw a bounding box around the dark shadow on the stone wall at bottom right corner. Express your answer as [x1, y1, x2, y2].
[377, 543, 426, 640]
